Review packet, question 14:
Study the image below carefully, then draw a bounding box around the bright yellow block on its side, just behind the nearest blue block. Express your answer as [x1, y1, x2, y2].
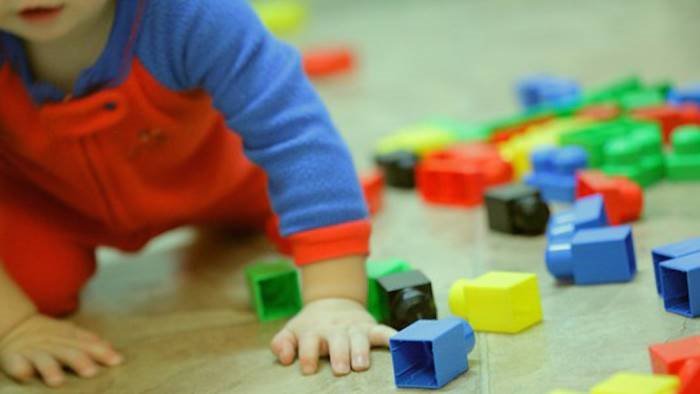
[449, 271, 542, 334]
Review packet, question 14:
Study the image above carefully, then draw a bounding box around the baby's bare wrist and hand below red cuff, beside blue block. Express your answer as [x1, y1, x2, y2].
[271, 256, 395, 375]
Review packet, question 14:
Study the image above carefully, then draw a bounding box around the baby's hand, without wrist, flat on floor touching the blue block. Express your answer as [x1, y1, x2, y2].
[270, 298, 396, 375]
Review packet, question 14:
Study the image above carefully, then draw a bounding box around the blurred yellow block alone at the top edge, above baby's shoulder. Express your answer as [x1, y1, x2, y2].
[253, 0, 306, 35]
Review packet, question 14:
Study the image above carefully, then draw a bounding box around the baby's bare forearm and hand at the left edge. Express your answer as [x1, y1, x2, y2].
[0, 262, 122, 386]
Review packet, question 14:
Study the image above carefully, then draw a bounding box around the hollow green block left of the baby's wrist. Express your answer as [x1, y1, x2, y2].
[245, 260, 302, 321]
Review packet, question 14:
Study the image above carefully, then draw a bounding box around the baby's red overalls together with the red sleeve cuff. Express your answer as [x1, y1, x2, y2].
[0, 60, 369, 315]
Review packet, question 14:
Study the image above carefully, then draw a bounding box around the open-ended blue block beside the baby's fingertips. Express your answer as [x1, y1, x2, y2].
[389, 318, 476, 389]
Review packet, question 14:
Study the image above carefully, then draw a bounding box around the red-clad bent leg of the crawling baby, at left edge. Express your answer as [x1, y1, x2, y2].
[0, 193, 95, 316]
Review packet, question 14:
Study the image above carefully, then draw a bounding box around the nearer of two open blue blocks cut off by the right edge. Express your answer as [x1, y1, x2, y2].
[659, 253, 700, 317]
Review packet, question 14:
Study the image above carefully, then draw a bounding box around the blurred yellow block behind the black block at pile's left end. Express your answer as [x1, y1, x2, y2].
[377, 125, 457, 156]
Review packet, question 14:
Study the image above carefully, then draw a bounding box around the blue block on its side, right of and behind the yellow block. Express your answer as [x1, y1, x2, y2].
[545, 226, 637, 285]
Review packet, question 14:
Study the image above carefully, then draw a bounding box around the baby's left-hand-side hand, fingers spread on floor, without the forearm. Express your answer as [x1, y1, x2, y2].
[0, 314, 123, 387]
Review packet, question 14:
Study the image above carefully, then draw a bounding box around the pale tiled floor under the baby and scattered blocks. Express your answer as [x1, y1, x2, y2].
[0, 0, 700, 394]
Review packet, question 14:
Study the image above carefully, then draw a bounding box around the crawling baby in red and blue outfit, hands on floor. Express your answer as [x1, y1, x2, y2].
[0, 0, 393, 386]
